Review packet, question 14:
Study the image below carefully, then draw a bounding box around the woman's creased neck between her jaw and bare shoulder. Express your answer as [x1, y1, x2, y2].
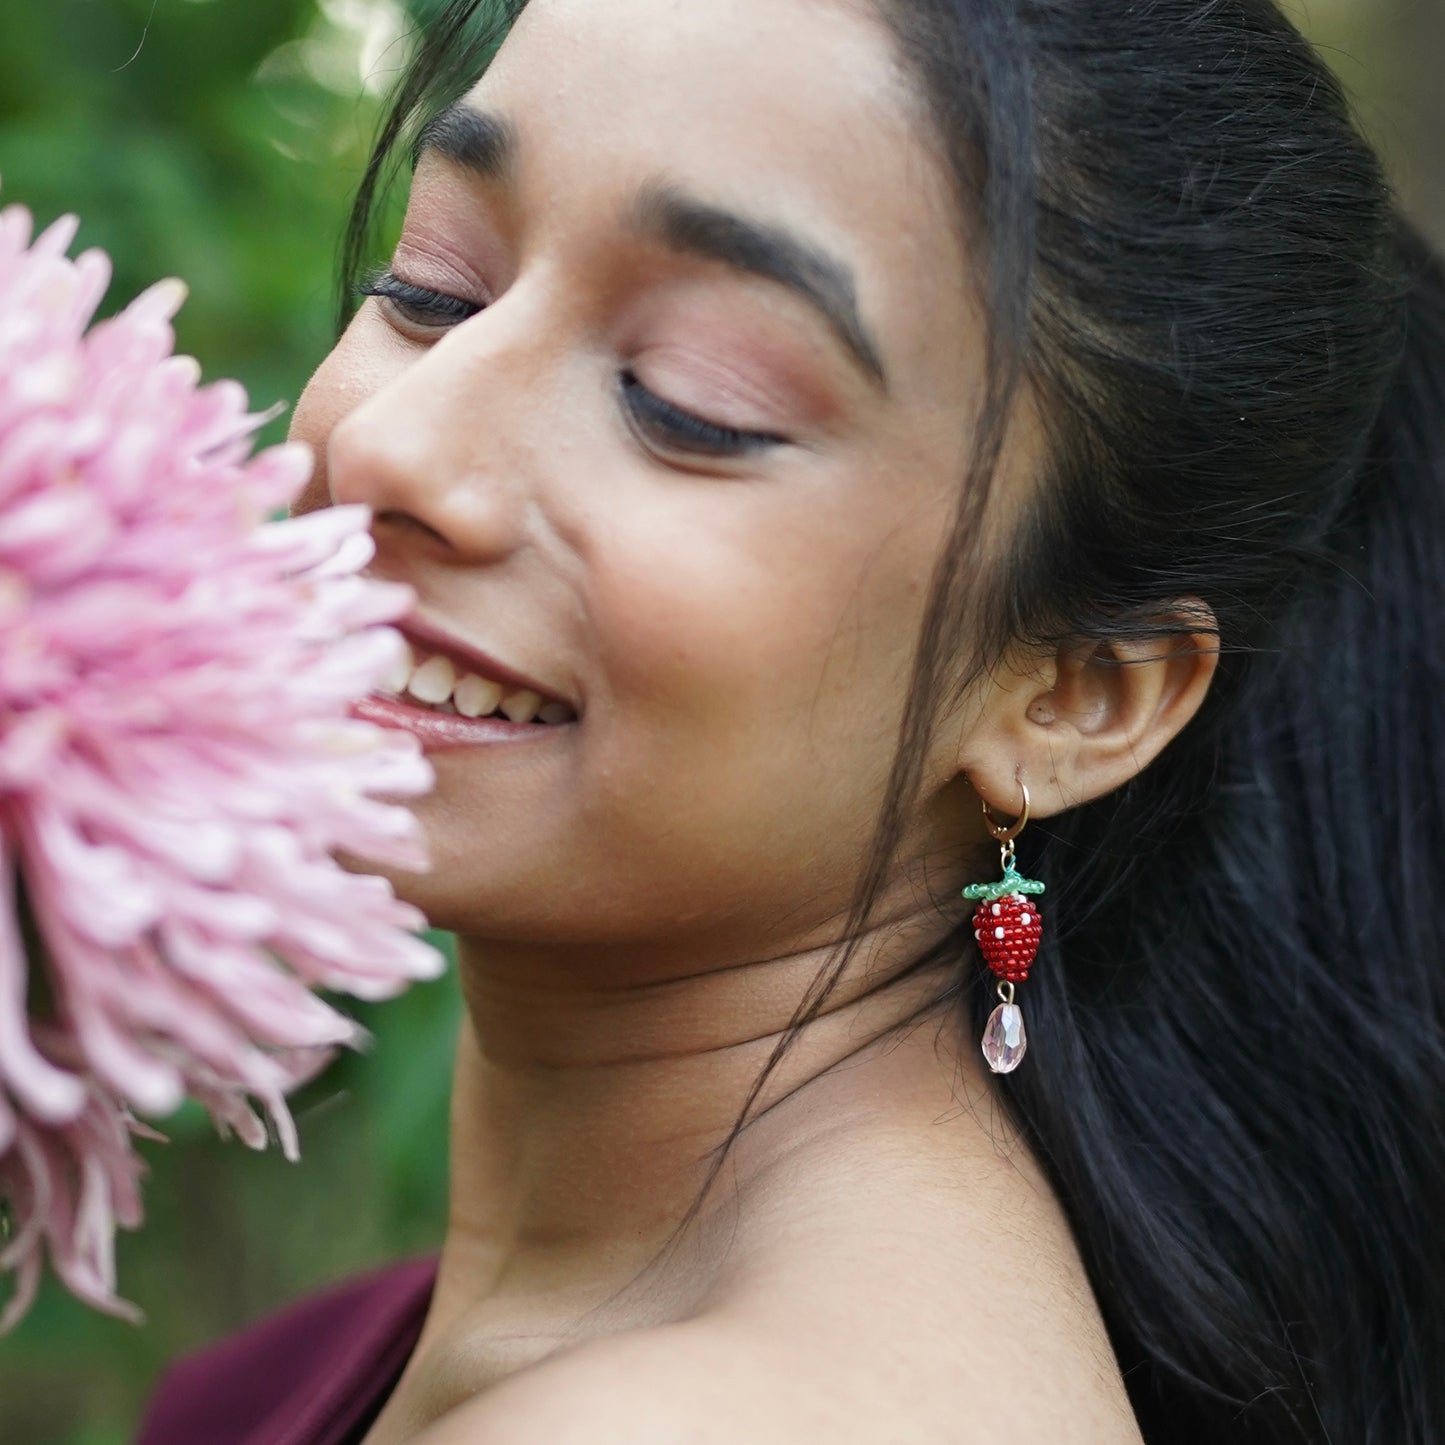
[423, 912, 948, 1342]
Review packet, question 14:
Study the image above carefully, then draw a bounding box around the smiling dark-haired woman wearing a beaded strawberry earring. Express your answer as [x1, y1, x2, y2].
[132, 0, 1445, 1445]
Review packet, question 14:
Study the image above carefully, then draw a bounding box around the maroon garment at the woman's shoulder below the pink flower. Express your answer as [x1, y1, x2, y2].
[136, 1259, 436, 1445]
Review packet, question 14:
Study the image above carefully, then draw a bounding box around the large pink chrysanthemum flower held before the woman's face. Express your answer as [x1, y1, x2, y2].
[0, 207, 442, 1331]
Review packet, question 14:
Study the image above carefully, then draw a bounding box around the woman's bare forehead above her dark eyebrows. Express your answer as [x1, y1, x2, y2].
[470, 0, 974, 394]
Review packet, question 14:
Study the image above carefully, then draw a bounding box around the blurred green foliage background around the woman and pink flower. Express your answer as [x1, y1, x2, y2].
[0, 0, 1445, 1445]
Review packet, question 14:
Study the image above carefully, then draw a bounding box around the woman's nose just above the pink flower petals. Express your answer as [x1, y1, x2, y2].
[327, 303, 543, 564]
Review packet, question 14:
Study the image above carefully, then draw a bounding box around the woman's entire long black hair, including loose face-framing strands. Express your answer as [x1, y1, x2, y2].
[335, 0, 1445, 1445]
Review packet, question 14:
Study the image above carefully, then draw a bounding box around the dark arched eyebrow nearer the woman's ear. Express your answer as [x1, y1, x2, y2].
[631, 185, 889, 392]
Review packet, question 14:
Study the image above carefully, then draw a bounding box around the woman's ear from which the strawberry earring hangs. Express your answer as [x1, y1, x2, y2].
[958, 598, 1220, 818]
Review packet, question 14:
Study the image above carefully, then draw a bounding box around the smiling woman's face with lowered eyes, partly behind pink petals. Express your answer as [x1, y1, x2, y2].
[293, 0, 1017, 957]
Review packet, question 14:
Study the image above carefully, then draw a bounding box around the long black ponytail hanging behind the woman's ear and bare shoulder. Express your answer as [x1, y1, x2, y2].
[1005, 216, 1445, 1445]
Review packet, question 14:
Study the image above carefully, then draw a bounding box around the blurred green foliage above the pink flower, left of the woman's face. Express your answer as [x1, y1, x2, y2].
[0, 0, 406, 439]
